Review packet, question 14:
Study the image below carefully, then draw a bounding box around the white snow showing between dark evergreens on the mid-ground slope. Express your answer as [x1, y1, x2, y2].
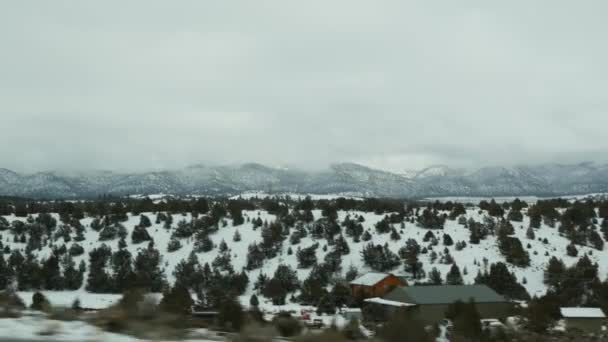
[1, 203, 608, 311]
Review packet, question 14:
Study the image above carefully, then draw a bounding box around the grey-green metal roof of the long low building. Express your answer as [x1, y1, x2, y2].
[383, 285, 507, 305]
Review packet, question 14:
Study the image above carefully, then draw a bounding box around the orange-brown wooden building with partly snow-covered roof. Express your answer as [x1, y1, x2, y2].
[350, 272, 407, 299]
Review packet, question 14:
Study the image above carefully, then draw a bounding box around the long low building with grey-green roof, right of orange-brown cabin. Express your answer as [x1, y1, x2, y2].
[382, 285, 513, 324]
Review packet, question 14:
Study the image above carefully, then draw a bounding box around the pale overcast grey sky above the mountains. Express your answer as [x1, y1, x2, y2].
[0, 0, 608, 172]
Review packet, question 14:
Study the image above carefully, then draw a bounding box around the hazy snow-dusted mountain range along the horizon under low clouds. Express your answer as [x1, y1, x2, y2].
[0, 162, 608, 199]
